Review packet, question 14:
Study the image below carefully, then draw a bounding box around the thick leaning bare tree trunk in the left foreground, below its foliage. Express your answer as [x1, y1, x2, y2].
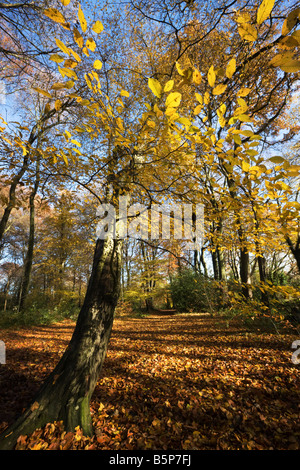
[0, 239, 122, 449]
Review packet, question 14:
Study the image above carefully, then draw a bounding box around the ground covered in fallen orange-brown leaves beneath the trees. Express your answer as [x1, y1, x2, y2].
[0, 314, 300, 450]
